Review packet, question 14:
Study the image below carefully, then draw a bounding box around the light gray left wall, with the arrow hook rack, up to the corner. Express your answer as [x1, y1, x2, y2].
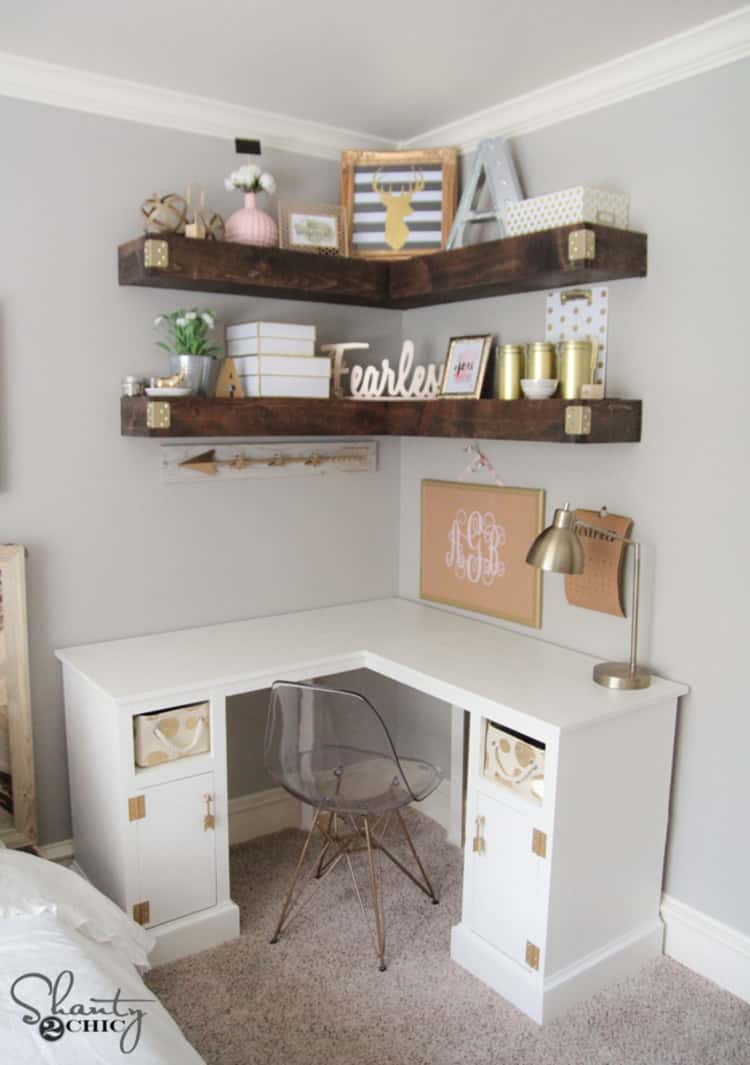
[0, 98, 401, 842]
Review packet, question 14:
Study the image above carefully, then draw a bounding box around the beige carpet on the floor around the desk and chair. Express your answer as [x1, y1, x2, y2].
[148, 814, 750, 1065]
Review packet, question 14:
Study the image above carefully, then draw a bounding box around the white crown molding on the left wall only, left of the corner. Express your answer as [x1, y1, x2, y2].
[0, 52, 395, 160]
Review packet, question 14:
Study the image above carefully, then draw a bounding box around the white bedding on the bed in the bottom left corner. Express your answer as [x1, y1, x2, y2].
[0, 851, 202, 1065]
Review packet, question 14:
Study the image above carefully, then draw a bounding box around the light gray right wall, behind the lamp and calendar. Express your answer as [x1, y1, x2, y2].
[400, 62, 750, 933]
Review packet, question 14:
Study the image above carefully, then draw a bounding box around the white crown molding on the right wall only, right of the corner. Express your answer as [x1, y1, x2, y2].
[398, 6, 750, 151]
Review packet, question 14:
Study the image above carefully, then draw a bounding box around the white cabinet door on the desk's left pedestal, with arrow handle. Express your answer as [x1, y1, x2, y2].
[135, 773, 216, 927]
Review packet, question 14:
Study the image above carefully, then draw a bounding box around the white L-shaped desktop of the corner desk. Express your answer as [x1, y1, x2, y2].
[56, 599, 687, 728]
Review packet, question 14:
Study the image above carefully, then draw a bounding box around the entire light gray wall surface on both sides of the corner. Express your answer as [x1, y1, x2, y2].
[0, 62, 750, 932]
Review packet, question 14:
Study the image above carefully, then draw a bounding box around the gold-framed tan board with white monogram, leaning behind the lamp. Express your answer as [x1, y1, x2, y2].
[420, 480, 544, 628]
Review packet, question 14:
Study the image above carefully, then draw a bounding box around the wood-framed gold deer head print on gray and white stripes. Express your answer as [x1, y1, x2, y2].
[341, 148, 458, 259]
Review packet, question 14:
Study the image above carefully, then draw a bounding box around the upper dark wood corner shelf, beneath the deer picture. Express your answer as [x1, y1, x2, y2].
[118, 223, 647, 310]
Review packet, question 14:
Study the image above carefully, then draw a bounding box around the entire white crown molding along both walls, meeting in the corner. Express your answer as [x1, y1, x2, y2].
[0, 5, 750, 159]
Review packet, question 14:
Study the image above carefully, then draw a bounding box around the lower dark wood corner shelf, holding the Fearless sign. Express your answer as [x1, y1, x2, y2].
[121, 396, 641, 444]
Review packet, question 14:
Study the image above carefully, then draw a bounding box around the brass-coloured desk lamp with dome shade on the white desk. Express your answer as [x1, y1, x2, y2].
[526, 503, 651, 691]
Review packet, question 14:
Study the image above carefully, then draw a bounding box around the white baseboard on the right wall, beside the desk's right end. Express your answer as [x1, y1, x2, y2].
[662, 895, 750, 1002]
